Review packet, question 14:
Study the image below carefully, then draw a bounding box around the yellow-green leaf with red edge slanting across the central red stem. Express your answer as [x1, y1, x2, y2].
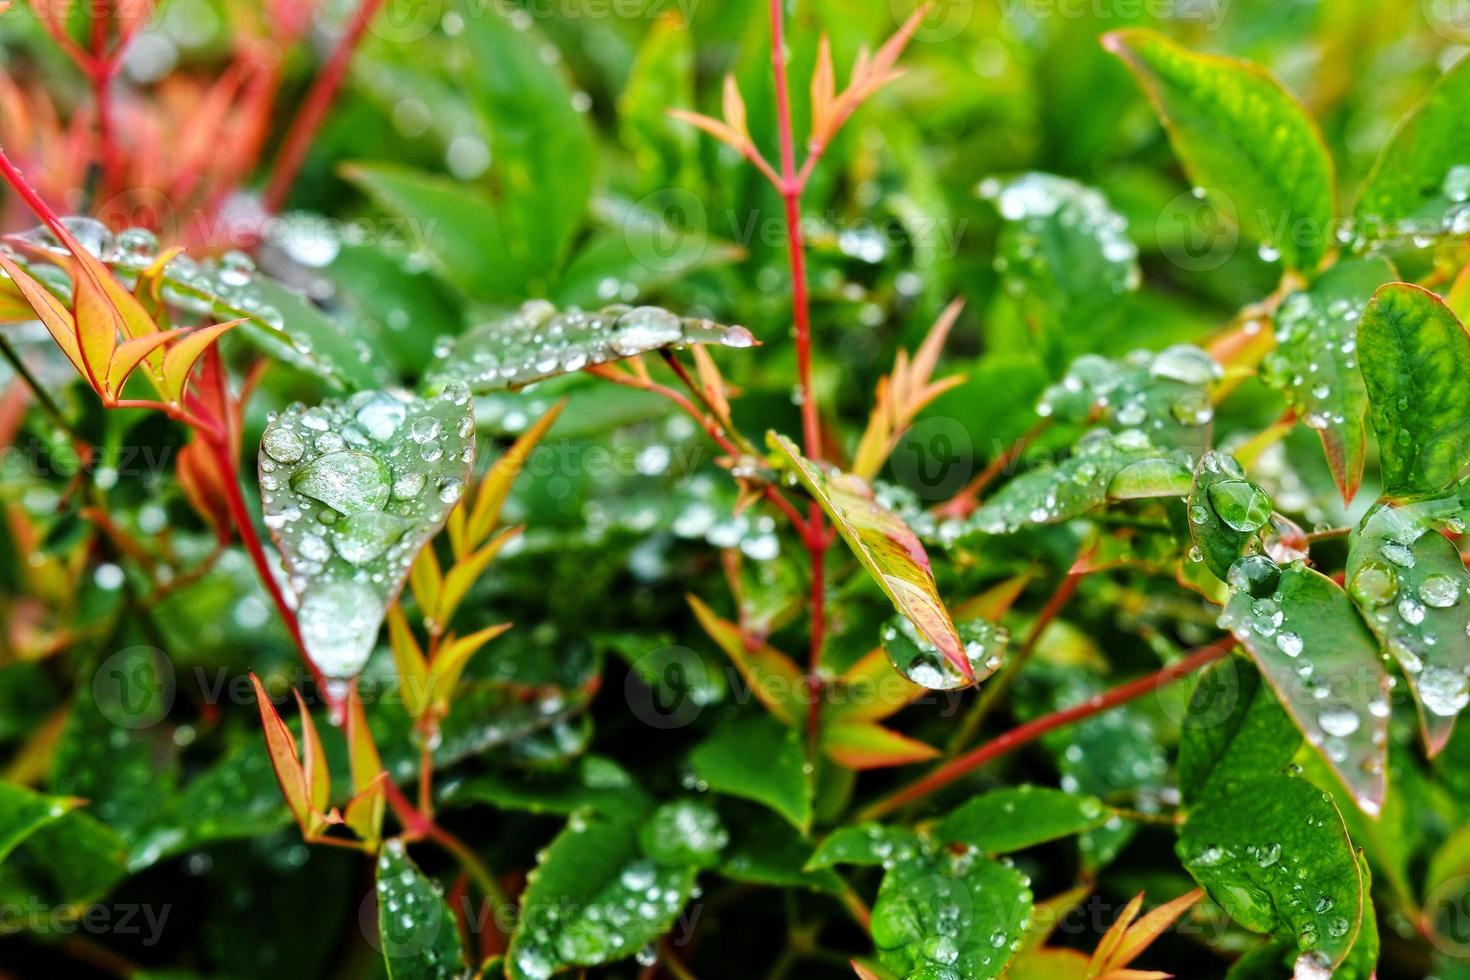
[766, 432, 976, 683]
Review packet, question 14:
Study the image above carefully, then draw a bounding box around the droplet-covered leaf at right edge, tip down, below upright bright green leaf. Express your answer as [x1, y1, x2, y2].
[1345, 498, 1470, 757]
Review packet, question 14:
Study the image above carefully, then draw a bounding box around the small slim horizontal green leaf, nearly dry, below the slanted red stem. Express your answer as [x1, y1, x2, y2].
[935, 786, 1113, 854]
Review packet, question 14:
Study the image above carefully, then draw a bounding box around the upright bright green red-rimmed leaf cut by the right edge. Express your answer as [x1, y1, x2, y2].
[1358, 282, 1470, 494]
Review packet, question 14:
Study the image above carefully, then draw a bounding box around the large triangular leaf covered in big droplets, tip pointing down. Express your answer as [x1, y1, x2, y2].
[260, 385, 475, 677]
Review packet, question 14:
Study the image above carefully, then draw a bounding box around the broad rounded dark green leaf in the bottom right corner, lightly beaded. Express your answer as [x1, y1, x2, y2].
[1176, 774, 1364, 976]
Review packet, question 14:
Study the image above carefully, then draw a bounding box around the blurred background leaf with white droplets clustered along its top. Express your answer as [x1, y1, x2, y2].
[980, 173, 1142, 364]
